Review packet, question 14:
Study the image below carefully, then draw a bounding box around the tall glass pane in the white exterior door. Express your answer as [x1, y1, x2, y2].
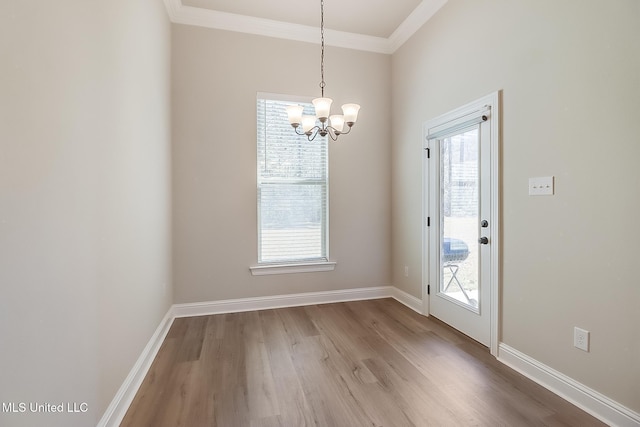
[439, 128, 480, 311]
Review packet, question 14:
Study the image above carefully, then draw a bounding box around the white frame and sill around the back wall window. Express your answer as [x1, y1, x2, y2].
[250, 92, 336, 276]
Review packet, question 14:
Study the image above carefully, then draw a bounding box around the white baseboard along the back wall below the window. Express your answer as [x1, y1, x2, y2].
[173, 286, 398, 317]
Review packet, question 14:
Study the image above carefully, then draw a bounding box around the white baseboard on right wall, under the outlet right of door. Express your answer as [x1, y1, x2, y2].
[498, 343, 640, 427]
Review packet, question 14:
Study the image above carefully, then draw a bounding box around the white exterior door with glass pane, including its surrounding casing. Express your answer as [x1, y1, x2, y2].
[424, 93, 498, 350]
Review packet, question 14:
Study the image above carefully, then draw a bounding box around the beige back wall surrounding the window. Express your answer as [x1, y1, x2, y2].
[172, 25, 391, 303]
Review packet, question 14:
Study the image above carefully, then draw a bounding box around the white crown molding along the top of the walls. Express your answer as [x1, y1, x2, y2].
[164, 0, 447, 54]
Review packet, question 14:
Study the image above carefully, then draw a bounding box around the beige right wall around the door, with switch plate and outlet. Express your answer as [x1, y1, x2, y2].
[392, 0, 640, 411]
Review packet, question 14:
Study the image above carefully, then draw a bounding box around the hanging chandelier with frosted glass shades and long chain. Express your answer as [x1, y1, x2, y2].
[287, 0, 360, 141]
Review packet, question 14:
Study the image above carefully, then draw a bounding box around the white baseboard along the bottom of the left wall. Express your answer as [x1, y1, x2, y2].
[97, 306, 175, 427]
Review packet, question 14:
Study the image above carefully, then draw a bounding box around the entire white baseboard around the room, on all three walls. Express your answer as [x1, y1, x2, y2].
[98, 286, 640, 427]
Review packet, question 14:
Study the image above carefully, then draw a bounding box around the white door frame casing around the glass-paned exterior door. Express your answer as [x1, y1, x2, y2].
[421, 92, 502, 357]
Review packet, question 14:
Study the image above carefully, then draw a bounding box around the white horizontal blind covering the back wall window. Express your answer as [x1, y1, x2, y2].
[257, 97, 328, 264]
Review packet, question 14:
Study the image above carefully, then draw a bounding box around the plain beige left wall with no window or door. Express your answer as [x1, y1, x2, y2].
[0, 0, 172, 427]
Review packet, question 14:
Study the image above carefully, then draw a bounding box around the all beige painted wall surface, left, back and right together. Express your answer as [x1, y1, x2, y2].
[0, 0, 640, 426]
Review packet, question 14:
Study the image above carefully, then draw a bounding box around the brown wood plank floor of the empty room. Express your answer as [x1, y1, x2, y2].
[121, 299, 604, 427]
